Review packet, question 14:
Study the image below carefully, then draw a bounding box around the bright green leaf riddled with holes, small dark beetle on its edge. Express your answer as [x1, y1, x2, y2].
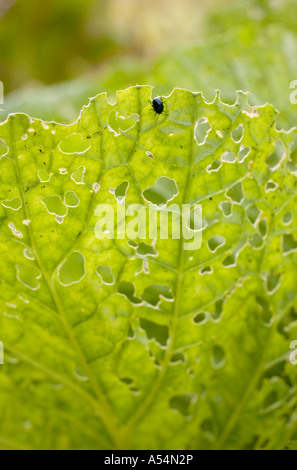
[0, 86, 297, 449]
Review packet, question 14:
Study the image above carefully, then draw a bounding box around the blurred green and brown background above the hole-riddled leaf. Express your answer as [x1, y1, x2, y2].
[0, 0, 297, 128]
